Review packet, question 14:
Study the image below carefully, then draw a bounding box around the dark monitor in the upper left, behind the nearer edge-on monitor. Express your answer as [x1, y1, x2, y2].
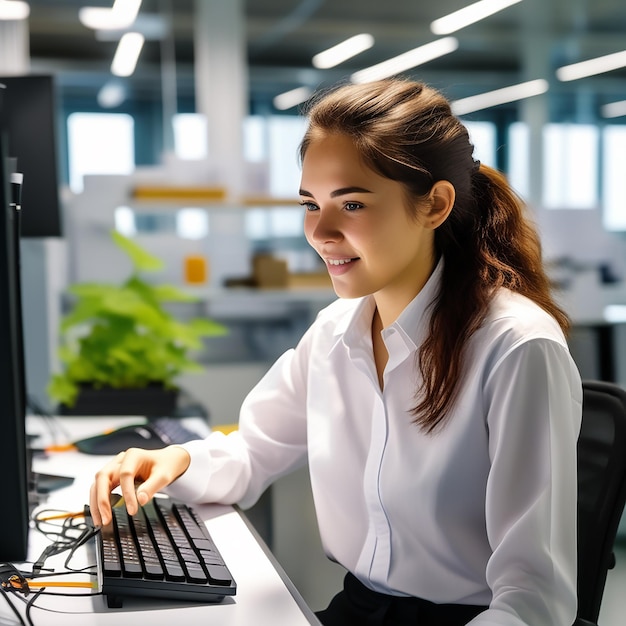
[0, 75, 62, 237]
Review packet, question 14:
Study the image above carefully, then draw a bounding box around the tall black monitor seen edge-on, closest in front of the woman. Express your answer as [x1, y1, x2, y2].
[0, 132, 30, 562]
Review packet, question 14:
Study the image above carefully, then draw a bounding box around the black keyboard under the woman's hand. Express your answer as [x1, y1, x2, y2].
[91, 497, 237, 606]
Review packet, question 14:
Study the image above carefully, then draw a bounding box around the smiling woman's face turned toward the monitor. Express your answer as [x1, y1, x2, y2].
[300, 134, 435, 313]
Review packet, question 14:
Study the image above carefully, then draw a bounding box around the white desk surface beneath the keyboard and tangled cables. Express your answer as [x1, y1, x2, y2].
[17, 418, 319, 626]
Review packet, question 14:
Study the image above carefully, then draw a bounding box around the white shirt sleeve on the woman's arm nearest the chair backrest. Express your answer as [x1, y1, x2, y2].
[469, 339, 582, 626]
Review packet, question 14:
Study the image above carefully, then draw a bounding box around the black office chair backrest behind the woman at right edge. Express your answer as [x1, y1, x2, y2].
[578, 380, 626, 623]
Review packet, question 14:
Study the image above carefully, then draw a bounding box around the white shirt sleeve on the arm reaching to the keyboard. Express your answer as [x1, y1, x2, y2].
[166, 335, 308, 508]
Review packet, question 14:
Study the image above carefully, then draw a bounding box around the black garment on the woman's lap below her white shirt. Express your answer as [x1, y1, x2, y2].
[316, 573, 487, 626]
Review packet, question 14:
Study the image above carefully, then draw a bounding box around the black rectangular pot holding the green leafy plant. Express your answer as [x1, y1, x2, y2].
[58, 384, 178, 417]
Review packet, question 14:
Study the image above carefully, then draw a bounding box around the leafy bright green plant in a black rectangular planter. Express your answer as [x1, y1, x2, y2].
[48, 231, 227, 415]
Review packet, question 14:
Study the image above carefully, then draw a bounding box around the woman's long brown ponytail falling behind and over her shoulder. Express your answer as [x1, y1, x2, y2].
[414, 164, 569, 432]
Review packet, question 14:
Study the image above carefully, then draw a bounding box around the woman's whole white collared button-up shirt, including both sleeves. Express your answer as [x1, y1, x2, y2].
[169, 266, 582, 626]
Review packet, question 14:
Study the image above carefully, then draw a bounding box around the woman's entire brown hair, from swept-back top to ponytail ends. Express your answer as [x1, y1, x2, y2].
[300, 79, 569, 432]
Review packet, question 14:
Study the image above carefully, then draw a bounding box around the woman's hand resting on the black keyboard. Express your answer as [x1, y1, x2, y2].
[89, 445, 191, 526]
